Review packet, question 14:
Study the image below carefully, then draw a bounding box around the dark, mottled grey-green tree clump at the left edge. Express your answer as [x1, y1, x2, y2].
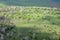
[0, 16, 15, 40]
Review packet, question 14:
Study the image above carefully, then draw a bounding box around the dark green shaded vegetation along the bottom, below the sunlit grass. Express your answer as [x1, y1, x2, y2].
[16, 27, 60, 40]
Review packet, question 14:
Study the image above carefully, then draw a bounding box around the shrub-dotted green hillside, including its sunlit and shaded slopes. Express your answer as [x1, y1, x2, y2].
[0, 7, 60, 40]
